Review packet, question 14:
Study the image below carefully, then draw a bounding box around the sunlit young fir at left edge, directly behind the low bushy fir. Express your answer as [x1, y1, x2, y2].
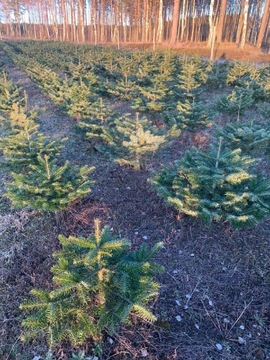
[0, 104, 62, 172]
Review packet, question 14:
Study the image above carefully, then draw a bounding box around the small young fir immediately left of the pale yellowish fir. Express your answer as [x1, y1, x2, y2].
[78, 98, 114, 139]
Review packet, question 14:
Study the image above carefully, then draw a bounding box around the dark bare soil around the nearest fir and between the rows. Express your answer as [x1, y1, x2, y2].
[0, 46, 270, 360]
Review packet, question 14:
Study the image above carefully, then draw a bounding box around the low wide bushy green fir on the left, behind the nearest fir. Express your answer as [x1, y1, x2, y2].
[6, 155, 93, 212]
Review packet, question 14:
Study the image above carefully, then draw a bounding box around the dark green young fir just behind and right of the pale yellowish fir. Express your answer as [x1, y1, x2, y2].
[164, 97, 210, 132]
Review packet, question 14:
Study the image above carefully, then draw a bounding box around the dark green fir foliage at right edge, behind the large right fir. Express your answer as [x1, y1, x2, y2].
[217, 121, 270, 153]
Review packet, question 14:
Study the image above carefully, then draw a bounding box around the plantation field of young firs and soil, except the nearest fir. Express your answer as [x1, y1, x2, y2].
[0, 41, 270, 360]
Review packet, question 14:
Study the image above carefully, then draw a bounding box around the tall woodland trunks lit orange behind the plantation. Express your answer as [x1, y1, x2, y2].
[0, 0, 270, 48]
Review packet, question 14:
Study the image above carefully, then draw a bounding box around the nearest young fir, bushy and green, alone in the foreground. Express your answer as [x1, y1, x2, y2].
[21, 220, 162, 350]
